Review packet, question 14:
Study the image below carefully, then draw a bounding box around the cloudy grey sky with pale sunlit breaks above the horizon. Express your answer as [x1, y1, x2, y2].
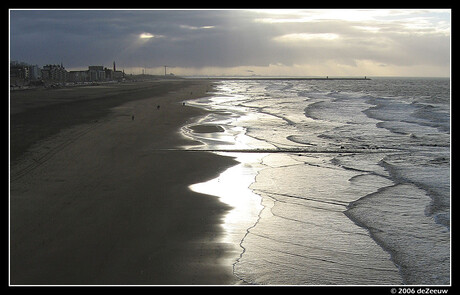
[10, 9, 451, 77]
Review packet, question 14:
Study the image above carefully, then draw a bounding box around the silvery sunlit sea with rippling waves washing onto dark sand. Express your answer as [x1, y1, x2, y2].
[182, 78, 451, 285]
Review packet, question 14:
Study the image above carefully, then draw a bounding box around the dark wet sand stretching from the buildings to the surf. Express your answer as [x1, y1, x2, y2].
[10, 80, 243, 285]
